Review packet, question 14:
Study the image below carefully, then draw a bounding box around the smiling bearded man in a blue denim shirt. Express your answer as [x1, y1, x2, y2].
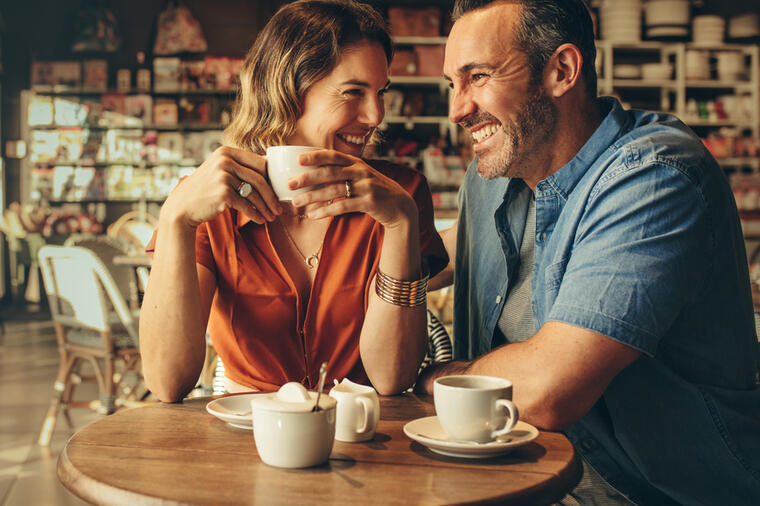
[418, 0, 760, 505]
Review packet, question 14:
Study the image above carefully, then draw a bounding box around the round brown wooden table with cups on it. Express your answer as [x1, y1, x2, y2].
[58, 394, 582, 506]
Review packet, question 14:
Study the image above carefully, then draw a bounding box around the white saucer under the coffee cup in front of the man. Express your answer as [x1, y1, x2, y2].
[404, 416, 538, 459]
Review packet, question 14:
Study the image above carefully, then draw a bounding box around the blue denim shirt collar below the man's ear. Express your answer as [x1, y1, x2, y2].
[536, 97, 631, 199]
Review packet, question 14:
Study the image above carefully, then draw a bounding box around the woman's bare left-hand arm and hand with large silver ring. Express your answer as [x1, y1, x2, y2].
[140, 147, 281, 402]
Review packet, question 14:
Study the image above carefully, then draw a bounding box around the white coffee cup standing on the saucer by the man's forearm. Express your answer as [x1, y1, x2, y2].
[433, 375, 519, 443]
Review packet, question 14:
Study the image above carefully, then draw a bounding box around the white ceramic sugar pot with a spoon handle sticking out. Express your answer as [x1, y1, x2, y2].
[251, 392, 337, 468]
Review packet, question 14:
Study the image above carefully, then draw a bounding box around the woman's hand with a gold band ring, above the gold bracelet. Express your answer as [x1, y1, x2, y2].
[288, 149, 417, 228]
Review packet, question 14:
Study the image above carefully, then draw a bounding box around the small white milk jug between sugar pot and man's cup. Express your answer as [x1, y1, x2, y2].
[330, 378, 380, 443]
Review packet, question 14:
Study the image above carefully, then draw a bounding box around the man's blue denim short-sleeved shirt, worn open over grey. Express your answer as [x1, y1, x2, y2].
[454, 99, 760, 505]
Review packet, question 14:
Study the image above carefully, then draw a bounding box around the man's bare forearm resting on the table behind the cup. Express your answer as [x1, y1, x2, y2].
[416, 322, 641, 430]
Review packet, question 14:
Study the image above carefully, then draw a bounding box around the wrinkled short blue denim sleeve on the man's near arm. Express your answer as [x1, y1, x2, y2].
[546, 163, 713, 356]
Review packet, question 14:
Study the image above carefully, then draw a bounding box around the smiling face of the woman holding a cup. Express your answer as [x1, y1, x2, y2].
[287, 41, 389, 156]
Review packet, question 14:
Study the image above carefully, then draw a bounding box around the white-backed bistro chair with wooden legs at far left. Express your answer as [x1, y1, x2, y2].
[38, 246, 141, 446]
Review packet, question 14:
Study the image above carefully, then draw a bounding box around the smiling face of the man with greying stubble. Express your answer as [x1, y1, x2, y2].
[444, 3, 556, 180]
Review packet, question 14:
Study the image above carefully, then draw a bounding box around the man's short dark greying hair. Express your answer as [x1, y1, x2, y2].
[451, 0, 597, 97]
